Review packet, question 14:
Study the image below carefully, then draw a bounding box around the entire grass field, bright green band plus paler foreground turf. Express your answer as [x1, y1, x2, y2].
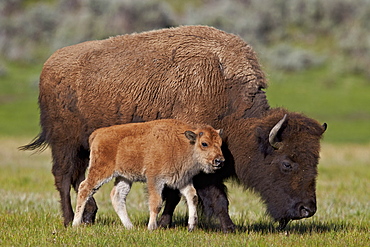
[0, 64, 370, 246]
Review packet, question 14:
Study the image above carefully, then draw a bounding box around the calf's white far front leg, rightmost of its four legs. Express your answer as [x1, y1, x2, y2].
[180, 184, 198, 232]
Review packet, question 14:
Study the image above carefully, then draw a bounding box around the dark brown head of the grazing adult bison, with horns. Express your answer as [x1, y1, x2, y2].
[248, 111, 326, 228]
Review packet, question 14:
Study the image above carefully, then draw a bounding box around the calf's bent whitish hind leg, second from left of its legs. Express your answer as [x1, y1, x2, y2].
[110, 177, 133, 229]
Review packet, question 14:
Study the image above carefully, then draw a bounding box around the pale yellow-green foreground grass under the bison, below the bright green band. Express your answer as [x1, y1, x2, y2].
[0, 138, 370, 246]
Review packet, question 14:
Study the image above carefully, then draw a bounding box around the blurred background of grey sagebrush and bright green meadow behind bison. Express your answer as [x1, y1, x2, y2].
[0, 0, 370, 144]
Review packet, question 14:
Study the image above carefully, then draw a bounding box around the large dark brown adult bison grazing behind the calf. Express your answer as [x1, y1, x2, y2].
[22, 26, 324, 231]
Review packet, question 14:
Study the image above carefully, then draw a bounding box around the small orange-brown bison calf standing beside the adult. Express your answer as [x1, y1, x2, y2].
[73, 119, 224, 231]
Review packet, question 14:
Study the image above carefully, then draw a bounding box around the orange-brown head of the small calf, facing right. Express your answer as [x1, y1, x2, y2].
[185, 126, 225, 173]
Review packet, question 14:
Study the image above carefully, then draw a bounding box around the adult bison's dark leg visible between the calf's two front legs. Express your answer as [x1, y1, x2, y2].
[158, 187, 181, 228]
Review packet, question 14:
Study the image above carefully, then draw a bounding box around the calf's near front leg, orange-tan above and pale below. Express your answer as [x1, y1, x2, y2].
[147, 178, 164, 230]
